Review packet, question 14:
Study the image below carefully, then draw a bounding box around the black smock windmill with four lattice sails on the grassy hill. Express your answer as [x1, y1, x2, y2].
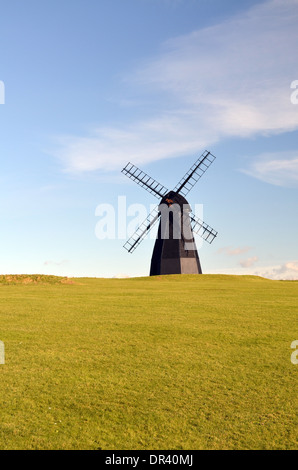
[122, 150, 217, 276]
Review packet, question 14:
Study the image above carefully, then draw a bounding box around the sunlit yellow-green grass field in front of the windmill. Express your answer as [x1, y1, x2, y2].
[0, 275, 298, 450]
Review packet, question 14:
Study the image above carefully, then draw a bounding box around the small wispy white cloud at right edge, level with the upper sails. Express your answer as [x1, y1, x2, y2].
[242, 151, 298, 186]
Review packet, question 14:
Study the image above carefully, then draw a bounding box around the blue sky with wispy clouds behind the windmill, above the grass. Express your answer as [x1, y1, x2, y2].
[0, 0, 298, 279]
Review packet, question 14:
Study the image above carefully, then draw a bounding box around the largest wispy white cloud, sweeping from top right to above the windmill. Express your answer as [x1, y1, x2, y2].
[52, 0, 298, 172]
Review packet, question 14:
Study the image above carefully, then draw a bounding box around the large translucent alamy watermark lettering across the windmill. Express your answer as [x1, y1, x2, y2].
[95, 196, 203, 249]
